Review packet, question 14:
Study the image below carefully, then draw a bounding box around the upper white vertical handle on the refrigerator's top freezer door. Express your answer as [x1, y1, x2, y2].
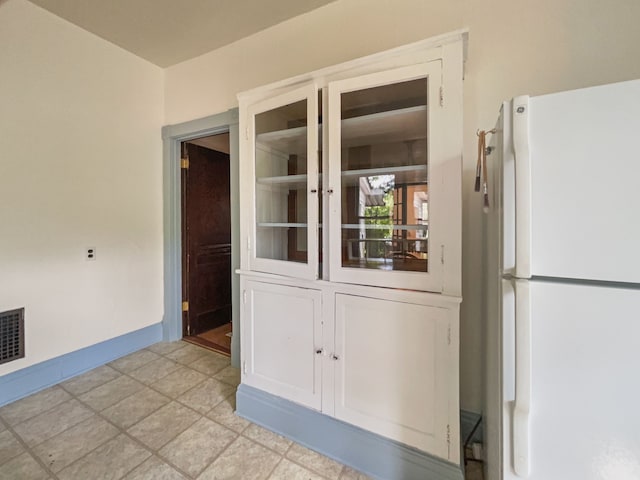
[512, 95, 531, 278]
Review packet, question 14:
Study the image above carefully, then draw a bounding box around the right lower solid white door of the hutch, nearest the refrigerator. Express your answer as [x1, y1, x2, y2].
[334, 294, 452, 458]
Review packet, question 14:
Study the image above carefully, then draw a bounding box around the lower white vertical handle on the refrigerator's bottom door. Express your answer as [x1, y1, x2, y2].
[513, 280, 531, 478]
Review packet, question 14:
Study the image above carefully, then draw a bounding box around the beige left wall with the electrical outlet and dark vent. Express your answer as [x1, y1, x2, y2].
[0, 0, 163, 376]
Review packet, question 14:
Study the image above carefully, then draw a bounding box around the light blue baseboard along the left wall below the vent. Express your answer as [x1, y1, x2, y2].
[0, 323, 162, 406]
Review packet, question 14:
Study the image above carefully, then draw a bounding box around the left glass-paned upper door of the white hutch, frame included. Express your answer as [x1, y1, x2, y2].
[248, 81, 318, 278]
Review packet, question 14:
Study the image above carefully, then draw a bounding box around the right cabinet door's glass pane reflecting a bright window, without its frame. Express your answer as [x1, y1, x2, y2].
[341, 78, 429, 272]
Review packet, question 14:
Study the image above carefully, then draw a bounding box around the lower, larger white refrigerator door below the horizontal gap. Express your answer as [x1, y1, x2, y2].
[502, 280, 640, 480]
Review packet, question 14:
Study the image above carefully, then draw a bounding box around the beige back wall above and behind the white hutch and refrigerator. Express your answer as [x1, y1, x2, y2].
[165, 0, 640, 411]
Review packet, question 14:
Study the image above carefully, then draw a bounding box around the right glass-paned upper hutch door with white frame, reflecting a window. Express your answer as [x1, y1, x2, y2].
[328, 62, 441, 291]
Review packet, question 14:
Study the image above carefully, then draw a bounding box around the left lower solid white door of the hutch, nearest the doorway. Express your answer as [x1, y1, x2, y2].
[242, 281, 322, 410]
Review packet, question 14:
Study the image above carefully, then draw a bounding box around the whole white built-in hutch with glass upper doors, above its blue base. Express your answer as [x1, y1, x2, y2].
[239, 34, 464, 463]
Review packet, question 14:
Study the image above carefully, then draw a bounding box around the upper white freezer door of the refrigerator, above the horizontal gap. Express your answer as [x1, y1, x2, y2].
[512, 80, 640, 283]
